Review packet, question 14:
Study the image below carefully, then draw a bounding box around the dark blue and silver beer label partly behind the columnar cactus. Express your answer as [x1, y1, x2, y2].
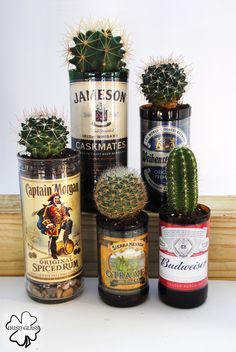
[141, 118, 189, 193]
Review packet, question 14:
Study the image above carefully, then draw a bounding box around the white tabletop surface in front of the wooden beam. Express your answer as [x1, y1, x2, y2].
[0, 277, 236, 352]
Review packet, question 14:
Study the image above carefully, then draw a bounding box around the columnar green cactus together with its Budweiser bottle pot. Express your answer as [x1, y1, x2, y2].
[159, 147, 210, 308]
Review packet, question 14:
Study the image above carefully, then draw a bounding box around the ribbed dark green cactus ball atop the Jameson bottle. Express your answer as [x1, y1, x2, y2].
[67, 22, 127, 72]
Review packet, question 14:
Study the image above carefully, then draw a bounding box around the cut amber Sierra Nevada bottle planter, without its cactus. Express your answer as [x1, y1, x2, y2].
[97, 212, 149, 307]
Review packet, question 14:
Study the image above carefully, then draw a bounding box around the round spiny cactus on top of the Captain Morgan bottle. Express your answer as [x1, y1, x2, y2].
[19, 111, 69, 159]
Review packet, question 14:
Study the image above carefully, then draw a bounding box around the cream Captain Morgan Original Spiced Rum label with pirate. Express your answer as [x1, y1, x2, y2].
[21, 174, 82, 283]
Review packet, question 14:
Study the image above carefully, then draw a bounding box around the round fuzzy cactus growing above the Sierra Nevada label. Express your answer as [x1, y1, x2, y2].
[94, 167, 147, 219]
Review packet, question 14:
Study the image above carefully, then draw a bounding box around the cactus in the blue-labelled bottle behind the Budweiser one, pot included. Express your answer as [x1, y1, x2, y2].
[140, 59, 191, 211]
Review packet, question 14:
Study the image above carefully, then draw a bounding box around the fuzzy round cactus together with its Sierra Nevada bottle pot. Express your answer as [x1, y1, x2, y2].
[95, 167, 149, 307]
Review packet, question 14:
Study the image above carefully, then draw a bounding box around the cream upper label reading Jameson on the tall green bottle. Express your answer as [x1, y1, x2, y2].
[70, 80, 127, 140]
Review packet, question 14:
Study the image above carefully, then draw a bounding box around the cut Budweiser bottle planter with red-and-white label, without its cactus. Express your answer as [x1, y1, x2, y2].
[158, 204, 210, 308]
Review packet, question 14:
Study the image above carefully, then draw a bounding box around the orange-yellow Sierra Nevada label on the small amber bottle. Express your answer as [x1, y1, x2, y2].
[100, 233, 148, 292]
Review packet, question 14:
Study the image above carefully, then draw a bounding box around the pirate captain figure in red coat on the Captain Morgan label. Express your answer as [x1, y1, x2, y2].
[37, 192, 74, 259]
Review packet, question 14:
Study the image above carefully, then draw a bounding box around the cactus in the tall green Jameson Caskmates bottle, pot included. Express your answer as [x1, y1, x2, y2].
[67, 21, 128, 212]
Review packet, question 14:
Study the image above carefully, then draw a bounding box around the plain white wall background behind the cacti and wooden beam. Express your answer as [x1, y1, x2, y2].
[0, 0, 236, 195]
